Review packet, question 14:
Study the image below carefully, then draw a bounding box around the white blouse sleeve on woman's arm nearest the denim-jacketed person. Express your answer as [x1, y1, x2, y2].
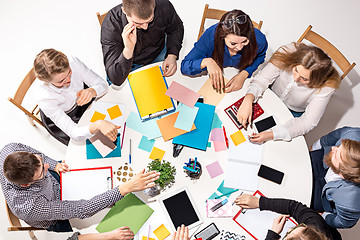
[272, 87, 335, 141]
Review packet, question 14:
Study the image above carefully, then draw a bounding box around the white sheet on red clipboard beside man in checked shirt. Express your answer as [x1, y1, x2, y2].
[61, 167, 112, 201]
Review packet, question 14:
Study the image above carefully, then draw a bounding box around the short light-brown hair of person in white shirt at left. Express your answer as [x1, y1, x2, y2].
[34, 48, 70, 82]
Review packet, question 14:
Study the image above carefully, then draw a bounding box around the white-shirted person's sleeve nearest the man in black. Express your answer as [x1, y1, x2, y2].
[72, 57, 109, 97]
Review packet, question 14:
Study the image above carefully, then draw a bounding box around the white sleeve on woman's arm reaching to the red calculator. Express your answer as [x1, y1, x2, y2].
[246, 62, 282, 102]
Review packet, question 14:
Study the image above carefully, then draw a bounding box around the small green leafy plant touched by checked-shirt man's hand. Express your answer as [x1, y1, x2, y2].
[148, 160, 176, 188]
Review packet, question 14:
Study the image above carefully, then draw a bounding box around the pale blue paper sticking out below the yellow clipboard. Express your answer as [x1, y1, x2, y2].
[126, 112, 161, 139]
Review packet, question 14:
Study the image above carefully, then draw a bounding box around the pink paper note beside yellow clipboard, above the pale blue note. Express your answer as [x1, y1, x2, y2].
[165, 81, 200, 108]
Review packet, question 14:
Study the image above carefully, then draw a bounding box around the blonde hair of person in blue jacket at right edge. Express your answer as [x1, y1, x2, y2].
[339, 139, 360, 184]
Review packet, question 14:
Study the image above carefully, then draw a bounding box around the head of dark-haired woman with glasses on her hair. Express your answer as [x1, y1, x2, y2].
[212, 9, 257, 70]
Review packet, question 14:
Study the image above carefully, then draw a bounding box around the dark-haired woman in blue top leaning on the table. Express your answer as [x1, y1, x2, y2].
[181, 10, 267, 92]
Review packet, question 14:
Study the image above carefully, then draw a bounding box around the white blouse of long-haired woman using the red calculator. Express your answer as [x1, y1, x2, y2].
[247, 43, 335, 141]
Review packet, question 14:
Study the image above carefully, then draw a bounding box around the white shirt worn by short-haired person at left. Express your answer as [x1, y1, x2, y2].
[35, 56, 109, 140]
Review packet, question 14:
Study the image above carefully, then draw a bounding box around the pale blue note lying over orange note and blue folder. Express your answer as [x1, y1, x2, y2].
[174, 104, 199, 132]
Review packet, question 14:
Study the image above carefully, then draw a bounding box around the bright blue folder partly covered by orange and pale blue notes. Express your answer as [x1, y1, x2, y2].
[173, 102, 215, 151]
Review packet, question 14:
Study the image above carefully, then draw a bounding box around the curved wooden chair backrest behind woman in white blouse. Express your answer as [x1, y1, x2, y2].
[298, 25, 356, 79]
